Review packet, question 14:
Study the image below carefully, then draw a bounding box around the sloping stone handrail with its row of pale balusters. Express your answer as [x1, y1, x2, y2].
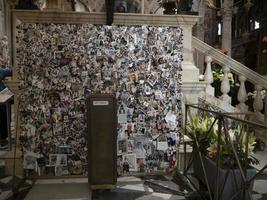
[192, 37, 267, 121]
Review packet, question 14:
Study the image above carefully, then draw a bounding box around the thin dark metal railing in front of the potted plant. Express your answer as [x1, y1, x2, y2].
[182, 105, 267, 200]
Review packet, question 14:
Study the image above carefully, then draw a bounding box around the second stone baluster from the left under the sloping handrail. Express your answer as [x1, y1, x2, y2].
[220, 66, 232, 104]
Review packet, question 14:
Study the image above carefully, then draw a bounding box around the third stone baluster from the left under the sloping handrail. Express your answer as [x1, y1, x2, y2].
[236, 75, 248, 112]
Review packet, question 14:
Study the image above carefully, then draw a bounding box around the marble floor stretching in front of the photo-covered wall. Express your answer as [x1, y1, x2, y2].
[25, 177, 185, 200]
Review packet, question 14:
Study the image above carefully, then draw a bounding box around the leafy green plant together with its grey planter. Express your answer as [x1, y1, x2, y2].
[187, 115, 258, 200]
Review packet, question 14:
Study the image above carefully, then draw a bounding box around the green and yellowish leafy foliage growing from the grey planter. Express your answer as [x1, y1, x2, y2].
[187, 115, 259, 169]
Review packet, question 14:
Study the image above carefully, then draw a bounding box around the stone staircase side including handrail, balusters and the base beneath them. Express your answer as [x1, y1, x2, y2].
[192, 37, 267, 144]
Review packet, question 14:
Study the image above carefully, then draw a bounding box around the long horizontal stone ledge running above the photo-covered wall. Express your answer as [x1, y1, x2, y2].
[12, 10, 199, 27]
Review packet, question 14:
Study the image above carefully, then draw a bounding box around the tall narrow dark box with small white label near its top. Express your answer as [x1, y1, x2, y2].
[87, 95, 117, 185]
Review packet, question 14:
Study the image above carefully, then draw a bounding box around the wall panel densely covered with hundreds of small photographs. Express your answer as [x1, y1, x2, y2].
[17, 23, 182, 176]
